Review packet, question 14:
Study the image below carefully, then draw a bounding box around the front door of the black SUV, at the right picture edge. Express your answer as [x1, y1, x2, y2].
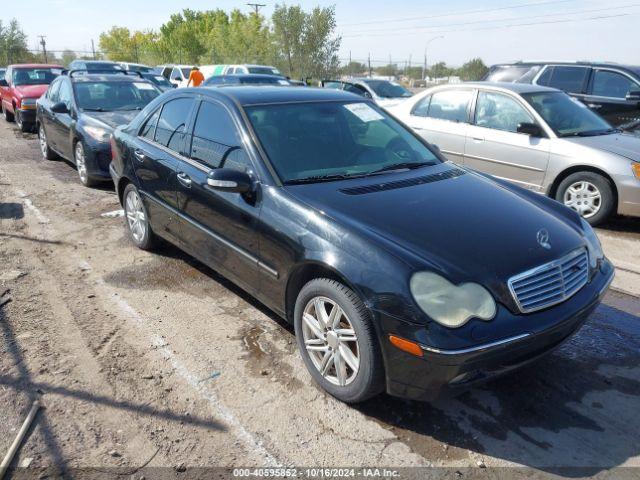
[585, 68, 640, 125]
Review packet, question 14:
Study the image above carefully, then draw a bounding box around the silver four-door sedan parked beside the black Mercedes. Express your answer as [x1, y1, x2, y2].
[391, 82, 640, 225]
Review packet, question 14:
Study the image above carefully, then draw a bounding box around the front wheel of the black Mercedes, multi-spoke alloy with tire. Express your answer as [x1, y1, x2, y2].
[294, 278, 384, 403]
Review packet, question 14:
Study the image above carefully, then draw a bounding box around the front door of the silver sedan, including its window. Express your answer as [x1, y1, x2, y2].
[464, 90, 550, 190]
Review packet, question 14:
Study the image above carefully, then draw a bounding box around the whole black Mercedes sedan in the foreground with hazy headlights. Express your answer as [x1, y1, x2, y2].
[110, 87, 613, 402]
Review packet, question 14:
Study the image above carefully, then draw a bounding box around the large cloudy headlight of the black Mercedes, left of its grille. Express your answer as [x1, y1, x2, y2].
[409, 272, 496, 328]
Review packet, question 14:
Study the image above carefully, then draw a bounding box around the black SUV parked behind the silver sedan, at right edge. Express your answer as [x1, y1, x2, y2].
[484, 62, 640, 126]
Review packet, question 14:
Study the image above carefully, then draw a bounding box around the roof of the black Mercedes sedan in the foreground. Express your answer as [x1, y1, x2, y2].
[178, 86, 367, 107]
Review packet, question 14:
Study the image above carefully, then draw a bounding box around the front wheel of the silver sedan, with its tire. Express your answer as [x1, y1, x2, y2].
[556, 172, 616, 226]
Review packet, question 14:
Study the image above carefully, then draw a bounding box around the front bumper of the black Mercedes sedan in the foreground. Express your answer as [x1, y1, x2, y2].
[379, 260, 614, 400]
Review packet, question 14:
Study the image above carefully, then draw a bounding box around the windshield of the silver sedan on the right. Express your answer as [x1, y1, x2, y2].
[522, 92, 617, 137]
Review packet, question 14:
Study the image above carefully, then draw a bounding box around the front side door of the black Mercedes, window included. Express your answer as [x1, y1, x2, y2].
[177, 100, 260, 292]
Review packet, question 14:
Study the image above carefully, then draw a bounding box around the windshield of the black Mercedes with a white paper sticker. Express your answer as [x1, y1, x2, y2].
[246, 102, 440, 184]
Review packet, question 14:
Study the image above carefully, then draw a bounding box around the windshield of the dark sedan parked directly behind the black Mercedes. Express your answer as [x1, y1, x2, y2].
[74, 81, 160, 112]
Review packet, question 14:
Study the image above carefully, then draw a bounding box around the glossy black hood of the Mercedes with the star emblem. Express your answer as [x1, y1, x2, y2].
[285, 164, 585, 296]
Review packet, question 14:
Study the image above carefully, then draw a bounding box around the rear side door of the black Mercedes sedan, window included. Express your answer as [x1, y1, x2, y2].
[131, 97, 195, 242]
